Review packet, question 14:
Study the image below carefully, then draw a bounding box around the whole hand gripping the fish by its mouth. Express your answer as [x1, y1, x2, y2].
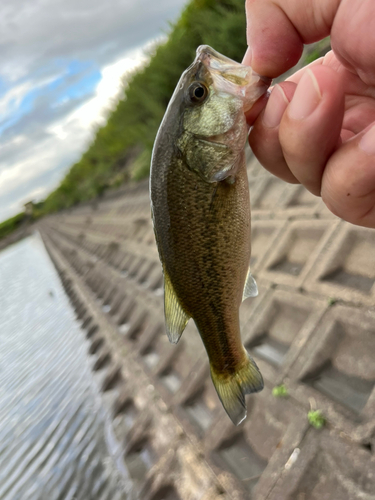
[243, 0, 375, 228]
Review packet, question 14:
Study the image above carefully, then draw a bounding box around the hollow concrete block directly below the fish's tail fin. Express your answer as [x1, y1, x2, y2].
[209, 388, 307, 500]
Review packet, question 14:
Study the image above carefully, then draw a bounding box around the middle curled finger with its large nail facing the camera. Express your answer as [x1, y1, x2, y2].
[279, 66, 345, 196]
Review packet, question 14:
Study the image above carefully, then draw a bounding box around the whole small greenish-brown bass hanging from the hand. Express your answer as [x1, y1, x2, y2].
[150, 45, 270, 425]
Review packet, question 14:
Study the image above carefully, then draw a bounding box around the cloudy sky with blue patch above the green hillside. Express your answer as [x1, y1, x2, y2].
[0, 0, 186, 221]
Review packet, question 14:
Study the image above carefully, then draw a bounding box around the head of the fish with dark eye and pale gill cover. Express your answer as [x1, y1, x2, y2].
[172, 45, 271, 182]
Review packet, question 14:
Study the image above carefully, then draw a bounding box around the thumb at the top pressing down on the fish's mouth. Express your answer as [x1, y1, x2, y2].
[244, 0, 340, 77]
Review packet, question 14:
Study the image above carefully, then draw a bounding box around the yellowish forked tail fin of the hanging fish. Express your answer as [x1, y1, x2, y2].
[210, 353, 264, 425]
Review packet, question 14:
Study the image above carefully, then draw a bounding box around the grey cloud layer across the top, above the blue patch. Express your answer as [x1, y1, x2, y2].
[0, 0, 184, 81]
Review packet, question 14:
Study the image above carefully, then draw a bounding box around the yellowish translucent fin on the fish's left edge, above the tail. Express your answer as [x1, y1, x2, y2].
[164, 272, 190, 344]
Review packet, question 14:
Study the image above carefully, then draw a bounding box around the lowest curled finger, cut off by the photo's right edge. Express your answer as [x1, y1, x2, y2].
[322, 124, 375, 228]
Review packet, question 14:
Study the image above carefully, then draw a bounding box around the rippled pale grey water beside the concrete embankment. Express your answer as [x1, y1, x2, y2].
[0, 235, 131, 500]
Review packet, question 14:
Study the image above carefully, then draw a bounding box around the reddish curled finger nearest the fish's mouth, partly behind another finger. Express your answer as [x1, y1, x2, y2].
[249, 82, 299, 183]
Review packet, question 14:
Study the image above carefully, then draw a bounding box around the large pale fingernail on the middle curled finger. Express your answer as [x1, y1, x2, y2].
[288, 69, 322, 120]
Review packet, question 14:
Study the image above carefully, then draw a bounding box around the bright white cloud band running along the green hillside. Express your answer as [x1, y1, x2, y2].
[0, 43, 153, 220]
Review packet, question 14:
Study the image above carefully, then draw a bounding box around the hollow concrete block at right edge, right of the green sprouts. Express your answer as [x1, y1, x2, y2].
[288, 305, 375, 442]
